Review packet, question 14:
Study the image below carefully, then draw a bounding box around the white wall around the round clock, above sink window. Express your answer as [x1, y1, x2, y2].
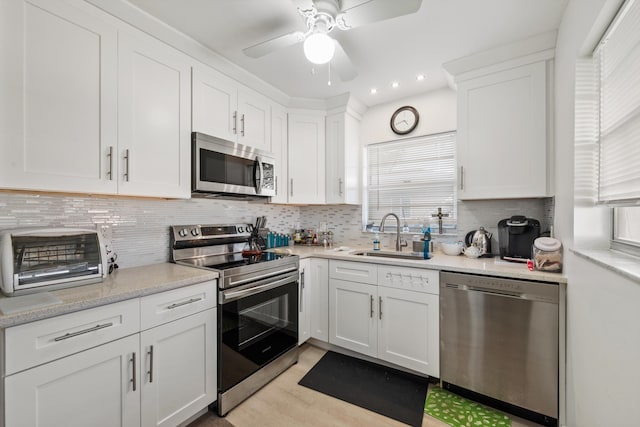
[360, 88, 457, 145]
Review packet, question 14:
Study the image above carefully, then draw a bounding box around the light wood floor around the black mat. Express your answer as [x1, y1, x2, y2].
[189, 344, 538, 427]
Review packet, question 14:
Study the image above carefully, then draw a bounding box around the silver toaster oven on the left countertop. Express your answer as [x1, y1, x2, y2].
[0, 228, 108, 296]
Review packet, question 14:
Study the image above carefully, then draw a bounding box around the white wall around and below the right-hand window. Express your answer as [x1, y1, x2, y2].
[555, 0, 640, 427]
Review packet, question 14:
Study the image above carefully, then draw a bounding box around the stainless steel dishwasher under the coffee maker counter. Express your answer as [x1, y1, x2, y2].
[440, 272, 559, 426]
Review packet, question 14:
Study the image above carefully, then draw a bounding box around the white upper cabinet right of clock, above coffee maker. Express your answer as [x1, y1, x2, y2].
[457, 61, 549, 199]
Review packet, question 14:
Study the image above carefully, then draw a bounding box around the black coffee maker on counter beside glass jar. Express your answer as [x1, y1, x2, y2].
[498, 215, 540, 262]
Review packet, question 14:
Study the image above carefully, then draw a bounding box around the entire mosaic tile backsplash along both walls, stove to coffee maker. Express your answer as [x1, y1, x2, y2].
[0, 193, 553, 267]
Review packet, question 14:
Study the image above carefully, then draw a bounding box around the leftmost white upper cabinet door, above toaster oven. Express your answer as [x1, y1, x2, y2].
[0, 0, 117, 193]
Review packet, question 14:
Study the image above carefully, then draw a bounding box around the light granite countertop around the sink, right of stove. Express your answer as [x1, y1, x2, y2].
[281, 245, 567, 283]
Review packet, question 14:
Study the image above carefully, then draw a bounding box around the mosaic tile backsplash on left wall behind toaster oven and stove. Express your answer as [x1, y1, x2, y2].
[0, 193, 300, 267]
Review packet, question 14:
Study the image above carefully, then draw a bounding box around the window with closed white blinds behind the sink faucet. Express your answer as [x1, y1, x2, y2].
[363, 132, 457, 234]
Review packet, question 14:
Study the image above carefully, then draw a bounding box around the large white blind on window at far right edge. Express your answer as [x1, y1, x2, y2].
[594, 0, 640, 205]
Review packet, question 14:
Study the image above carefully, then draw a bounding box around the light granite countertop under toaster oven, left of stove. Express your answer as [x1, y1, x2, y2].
[0, 263, 218, 328]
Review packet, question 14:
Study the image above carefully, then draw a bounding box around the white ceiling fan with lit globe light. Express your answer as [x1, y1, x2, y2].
[243, 0, 422, 81]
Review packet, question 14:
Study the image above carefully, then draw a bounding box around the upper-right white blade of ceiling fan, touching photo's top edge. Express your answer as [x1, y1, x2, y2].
[337, 0, 422, 29]
